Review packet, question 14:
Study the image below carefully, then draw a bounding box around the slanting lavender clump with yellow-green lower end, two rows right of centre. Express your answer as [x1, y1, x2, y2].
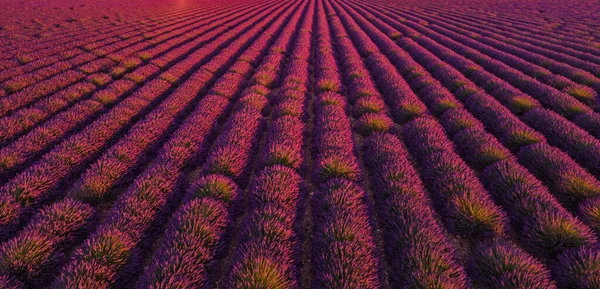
[403, 118, 505, 237]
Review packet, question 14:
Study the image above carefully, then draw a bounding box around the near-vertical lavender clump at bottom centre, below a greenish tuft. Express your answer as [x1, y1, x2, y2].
[313, 179, 378, 288]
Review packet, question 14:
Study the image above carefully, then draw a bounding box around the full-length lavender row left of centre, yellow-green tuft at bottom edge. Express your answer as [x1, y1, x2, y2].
[225, 1, 314, 288]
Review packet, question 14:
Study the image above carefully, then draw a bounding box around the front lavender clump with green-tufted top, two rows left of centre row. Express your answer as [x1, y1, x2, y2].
[141, 175, 240, 287]
